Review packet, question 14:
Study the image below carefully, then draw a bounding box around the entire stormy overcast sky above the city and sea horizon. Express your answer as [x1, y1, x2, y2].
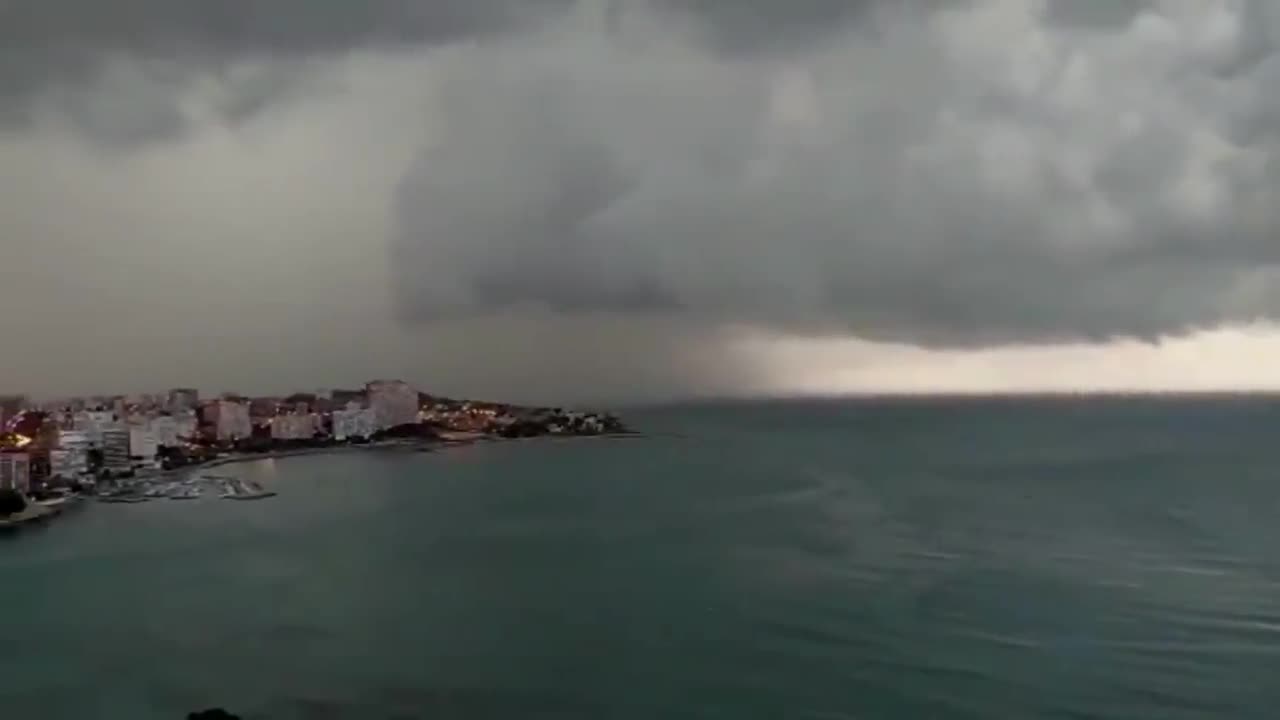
[0, 0, 1280, 402]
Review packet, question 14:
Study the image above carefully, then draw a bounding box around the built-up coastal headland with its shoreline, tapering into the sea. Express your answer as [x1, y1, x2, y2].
[0, 380, 643, 520]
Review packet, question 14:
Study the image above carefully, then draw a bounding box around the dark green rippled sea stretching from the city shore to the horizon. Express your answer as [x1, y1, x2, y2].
[0, 397, 1280, 720]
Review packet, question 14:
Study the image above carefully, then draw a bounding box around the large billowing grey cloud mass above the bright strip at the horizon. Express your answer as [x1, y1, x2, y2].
[394, 0, 1280, 346]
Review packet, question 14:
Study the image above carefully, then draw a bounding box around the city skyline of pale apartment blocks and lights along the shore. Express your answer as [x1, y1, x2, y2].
[0, 378, 626, 497]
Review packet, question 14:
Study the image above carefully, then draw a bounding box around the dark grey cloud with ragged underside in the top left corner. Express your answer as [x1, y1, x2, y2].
[0, 0, 572, 136]
